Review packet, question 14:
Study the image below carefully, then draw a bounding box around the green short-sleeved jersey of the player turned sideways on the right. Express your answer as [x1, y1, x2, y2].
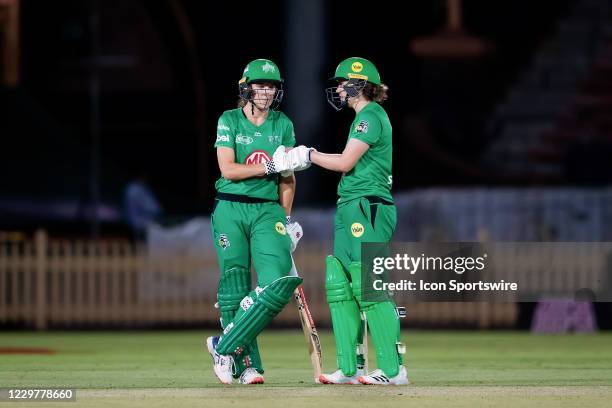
[338, 102, 393, 203]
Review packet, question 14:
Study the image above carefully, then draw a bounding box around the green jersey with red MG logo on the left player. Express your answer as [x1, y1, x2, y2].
[215, 108, 295, 200]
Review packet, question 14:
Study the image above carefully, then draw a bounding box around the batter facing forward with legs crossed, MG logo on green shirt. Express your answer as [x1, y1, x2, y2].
[206, 59, 308, 384]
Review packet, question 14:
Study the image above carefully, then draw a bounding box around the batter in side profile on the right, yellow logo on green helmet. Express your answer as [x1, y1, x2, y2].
[289, 57, 408, 385]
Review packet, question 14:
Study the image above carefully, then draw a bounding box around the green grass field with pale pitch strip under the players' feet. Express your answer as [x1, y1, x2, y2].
[0, 330, 612, 408]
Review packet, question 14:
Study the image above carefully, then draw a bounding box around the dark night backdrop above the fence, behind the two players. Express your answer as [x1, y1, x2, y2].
[0, 0, 612, 328]
